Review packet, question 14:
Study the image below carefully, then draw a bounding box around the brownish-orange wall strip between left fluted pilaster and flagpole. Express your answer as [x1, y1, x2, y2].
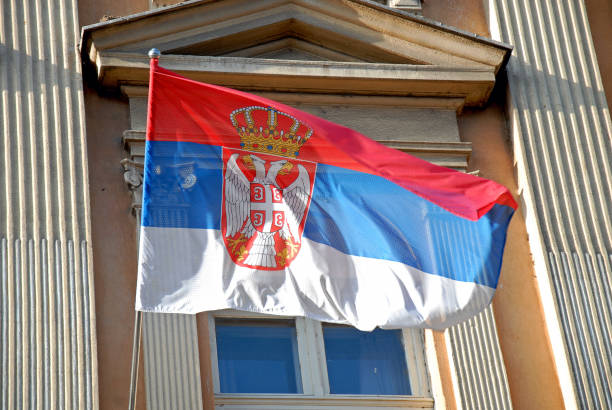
[85, 88, 145, 409]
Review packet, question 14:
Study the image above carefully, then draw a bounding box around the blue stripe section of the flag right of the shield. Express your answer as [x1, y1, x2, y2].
[304, 164, 512, 288]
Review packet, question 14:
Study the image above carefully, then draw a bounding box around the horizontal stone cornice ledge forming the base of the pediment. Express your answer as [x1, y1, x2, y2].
[96, 52, 495, 105]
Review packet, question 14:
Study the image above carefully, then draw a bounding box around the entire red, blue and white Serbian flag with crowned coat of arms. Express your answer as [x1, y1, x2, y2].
[136, 59, 516, 330]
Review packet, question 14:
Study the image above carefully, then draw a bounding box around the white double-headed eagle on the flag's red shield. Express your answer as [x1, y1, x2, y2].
[225, 154, 310, 268]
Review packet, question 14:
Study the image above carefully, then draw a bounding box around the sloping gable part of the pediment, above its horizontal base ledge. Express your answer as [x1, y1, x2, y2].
[84, 0, 506, 67]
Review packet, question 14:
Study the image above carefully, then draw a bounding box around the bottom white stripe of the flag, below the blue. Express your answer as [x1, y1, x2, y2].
[136, 227, 494, 330]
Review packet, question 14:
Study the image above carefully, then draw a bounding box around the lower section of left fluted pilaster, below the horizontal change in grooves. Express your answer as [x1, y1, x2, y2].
[0, 238, 97, 409]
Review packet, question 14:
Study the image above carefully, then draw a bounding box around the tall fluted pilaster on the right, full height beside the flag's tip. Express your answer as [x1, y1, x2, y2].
[489, 0, 612, 408]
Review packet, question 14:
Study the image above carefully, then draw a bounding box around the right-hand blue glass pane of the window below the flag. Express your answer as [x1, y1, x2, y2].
[323, 325, 410, 395]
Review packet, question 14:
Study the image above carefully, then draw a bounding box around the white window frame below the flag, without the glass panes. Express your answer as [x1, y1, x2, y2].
[208, 310, 433, 410]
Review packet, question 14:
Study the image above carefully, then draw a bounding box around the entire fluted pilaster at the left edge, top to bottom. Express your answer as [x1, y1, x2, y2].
[0, 0, 98, 409]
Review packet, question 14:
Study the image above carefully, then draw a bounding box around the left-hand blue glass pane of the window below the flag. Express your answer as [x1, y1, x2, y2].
[215, 319, 302, 393]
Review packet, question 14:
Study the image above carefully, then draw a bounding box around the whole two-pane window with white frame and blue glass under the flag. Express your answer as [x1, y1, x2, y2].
[209, 311, 433, 409]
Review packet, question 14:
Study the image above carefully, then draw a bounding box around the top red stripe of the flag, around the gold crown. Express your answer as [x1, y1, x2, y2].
[147, 59, 517, 220]
